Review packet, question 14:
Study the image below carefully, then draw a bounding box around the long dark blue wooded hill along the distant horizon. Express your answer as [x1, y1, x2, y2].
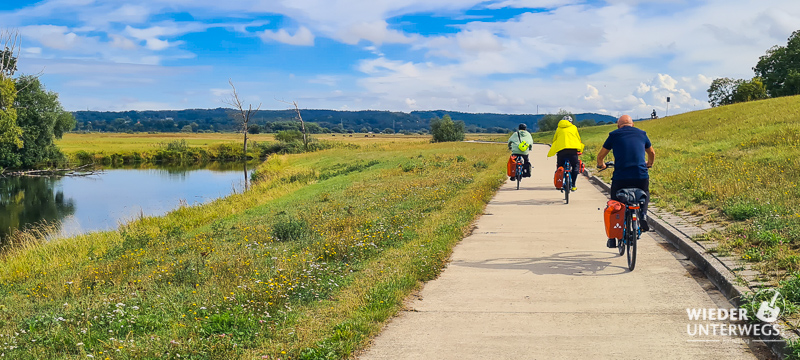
[73, 108, 616, 133]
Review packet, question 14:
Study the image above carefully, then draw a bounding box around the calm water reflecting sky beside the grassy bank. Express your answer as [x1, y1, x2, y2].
[0, 163, 252, 238]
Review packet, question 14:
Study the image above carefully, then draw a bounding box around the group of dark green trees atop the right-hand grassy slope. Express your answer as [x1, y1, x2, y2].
[708, 30, 800, 107]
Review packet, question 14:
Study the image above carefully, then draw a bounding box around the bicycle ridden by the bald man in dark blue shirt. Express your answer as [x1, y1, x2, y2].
[600, 161, 647, 271]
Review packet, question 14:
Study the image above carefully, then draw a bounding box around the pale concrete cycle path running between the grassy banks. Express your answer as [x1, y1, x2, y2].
[359, 145, 770, 360]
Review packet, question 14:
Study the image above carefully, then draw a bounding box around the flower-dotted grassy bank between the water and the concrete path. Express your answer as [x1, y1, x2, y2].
[0, 141, 506, 359]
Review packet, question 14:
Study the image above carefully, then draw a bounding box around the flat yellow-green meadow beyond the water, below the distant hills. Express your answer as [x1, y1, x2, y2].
[56, 133, 504, 165]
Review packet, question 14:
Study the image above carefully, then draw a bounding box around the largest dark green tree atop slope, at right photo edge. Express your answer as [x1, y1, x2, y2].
[753, 30, 800, 97]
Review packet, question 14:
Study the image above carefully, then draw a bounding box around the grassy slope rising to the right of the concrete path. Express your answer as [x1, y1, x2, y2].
[534, 97, 800, 290]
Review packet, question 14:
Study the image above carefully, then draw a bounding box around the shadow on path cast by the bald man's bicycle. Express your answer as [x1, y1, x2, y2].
[452, 251, 628, 276]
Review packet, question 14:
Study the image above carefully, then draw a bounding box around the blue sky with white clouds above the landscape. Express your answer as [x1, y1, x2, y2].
[0, 0, 800, 117]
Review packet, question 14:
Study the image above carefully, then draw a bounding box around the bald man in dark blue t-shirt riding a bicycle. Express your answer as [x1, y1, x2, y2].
[597, 115, 656, 248]
